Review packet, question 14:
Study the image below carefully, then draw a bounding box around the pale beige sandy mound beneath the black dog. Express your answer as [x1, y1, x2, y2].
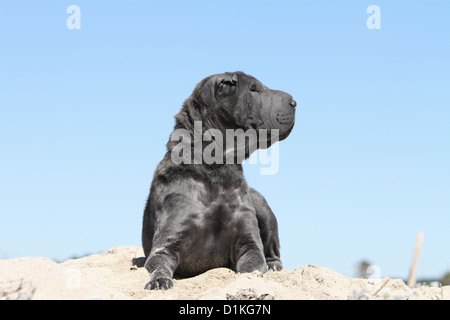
[0, 246, 450, 300]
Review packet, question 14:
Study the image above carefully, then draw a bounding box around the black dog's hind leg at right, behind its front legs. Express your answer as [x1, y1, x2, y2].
[250, 189, 283, 271]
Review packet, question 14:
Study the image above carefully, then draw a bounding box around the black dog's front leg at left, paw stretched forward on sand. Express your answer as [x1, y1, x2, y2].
[142, 180, 209, 290]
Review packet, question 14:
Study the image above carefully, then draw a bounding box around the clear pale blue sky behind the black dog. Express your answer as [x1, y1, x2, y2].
[0, 0, 450, 278]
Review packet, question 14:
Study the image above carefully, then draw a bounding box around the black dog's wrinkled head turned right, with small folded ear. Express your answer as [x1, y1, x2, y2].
[193, 72, 297, 144]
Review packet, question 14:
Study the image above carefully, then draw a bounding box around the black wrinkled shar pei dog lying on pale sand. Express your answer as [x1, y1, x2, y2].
[142, 72, 296, 290]
